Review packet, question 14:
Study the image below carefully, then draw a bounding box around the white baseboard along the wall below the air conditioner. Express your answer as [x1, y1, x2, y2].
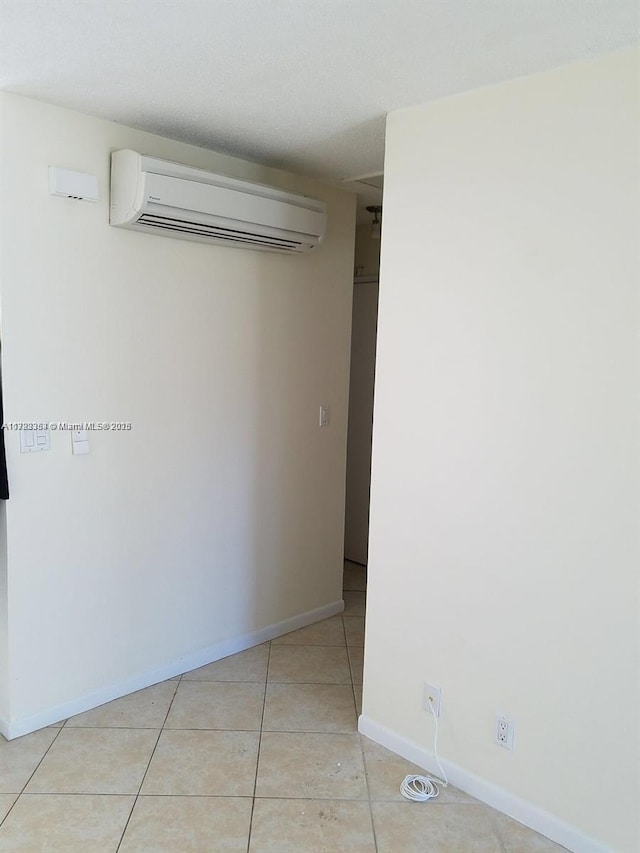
[0, 600, 344, 740]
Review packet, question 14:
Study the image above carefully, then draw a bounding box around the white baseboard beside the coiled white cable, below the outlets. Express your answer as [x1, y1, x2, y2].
[358, 714, 610, 853]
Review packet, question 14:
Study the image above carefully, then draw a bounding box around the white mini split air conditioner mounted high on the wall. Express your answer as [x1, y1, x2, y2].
[109, 150, 327, 252]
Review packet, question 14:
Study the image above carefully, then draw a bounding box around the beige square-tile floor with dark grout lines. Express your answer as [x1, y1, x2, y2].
[0, 563, 562, 853]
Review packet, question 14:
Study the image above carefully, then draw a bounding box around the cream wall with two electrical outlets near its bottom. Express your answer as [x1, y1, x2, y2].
[363, 51, 640, 853]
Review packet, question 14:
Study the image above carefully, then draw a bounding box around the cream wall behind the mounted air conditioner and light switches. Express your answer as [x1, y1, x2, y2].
[0, 95, 355, 733]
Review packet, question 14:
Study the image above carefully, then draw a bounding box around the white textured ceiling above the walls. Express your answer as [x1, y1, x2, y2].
[0, 0, 639, 211]
